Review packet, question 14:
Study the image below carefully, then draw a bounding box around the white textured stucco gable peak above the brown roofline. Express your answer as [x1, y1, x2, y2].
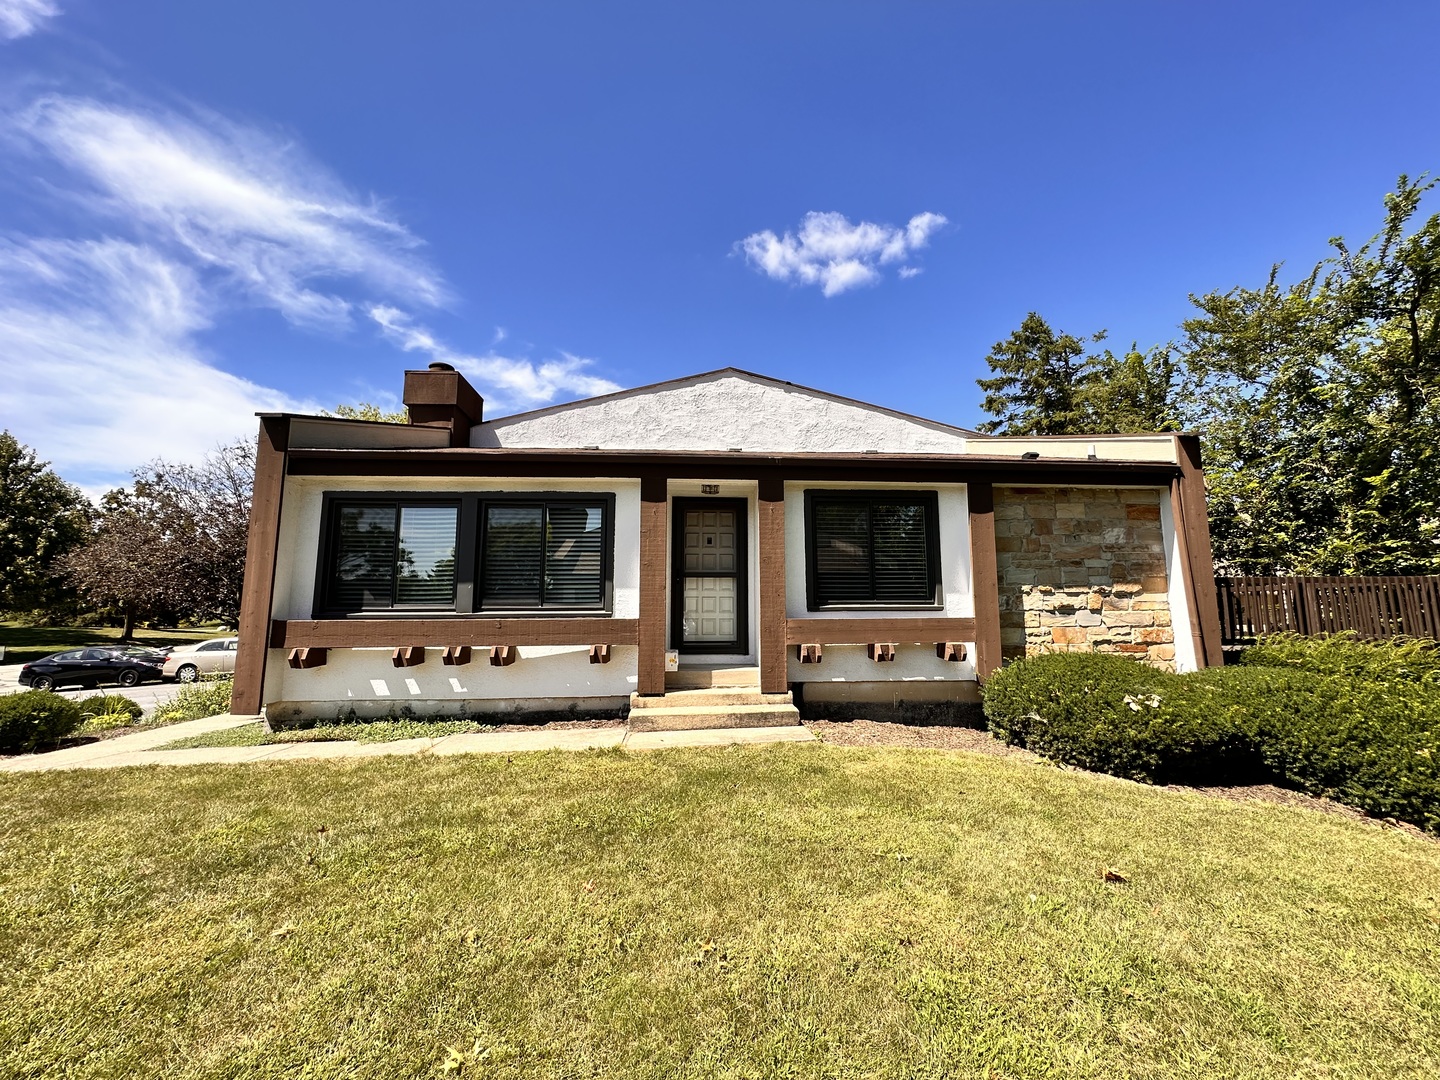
[471, 367, 976, 452]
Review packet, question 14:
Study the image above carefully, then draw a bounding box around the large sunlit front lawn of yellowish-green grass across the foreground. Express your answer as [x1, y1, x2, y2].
[0, 744, 1440, 1080]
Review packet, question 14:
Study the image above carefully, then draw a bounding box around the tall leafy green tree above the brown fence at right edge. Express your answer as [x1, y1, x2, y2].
[1179, 176, 1440, 573]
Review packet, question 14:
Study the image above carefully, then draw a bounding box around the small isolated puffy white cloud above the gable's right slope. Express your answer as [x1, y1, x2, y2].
[736, 210, 946, 297]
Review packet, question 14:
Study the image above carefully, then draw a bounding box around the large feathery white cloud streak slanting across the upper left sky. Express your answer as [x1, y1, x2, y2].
[16, 96, 445, 328]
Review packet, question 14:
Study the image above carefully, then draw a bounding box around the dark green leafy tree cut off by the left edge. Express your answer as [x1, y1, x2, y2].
[0, 431, 92, 611]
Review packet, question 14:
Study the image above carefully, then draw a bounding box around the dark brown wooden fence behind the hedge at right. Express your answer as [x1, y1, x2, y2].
[1215, 576, 1440, 645]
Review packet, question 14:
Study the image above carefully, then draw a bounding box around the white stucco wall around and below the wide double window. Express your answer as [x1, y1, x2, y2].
[265, 477, 639, 703]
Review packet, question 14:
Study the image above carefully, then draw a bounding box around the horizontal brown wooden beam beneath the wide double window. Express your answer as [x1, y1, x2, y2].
[269, 618, 636, 650]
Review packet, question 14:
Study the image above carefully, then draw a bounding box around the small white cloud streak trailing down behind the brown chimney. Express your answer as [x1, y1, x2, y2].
[369, 304, 621, 409]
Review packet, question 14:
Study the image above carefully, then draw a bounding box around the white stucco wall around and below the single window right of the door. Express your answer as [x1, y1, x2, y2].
[785, 482, 975, 683]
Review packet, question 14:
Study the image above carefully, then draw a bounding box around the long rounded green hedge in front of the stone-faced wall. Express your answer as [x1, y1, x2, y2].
[985, 654, 1440, 832]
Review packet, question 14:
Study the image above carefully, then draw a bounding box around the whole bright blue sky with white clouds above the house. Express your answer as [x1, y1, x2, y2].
[0, 0, 1440, 490]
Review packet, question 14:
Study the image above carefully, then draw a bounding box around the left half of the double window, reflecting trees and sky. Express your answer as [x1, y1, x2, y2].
[324, 500, 459, 612]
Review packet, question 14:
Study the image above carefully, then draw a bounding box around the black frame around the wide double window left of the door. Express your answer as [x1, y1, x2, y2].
[311, 491, 615, 619]
